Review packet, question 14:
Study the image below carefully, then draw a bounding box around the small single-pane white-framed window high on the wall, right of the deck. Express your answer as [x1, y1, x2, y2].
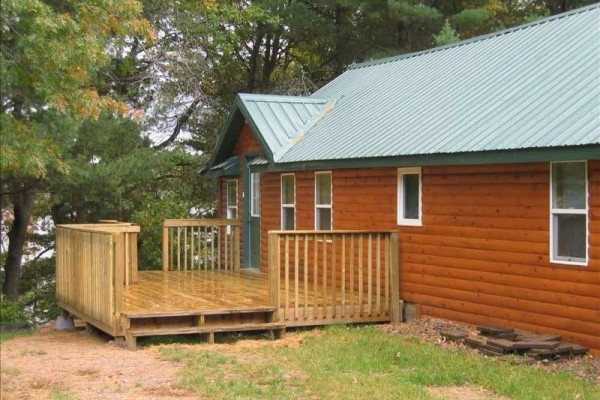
[398, 168, 422, 226]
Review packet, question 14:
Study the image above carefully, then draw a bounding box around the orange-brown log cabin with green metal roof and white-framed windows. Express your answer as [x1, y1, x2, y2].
[204, 4, 600, 351]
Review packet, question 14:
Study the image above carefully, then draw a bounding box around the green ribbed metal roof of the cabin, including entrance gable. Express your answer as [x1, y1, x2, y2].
[211, 4, 600, 168]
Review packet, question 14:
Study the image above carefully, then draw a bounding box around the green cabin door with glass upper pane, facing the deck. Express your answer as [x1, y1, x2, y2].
[244, 160, 260, 268]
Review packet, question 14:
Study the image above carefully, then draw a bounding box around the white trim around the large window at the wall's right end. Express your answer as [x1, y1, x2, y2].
[549, 160, 590, 267]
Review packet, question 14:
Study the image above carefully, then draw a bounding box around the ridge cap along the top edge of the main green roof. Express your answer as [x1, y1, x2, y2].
[348, 3, 600, 70]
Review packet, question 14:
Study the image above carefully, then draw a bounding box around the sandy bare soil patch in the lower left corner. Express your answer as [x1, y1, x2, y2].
[0, 327, 196, 400]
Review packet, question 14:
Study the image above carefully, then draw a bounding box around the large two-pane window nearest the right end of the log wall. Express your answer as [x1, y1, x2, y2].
[550, 161, 588, 265]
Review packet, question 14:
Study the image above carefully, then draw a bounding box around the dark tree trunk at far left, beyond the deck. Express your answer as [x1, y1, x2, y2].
[2, 189, 36, 301]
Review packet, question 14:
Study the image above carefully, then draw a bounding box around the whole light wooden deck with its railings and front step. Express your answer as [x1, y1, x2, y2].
[56, 220, 399, 349]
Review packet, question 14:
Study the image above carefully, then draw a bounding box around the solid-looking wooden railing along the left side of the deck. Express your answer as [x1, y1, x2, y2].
[56, 222, 140, 336]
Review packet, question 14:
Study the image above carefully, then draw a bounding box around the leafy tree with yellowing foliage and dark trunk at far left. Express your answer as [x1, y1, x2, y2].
[0, 0, 152, 300]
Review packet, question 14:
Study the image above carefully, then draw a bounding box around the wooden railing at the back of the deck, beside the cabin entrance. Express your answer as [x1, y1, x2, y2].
[162, 219, 241, 271]
